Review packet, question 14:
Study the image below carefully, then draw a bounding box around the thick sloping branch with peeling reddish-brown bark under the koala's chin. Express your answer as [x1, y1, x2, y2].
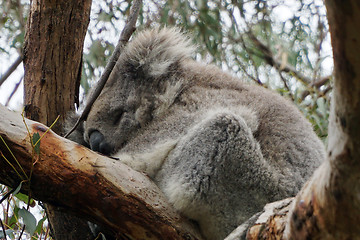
[0, 105, 201, 239]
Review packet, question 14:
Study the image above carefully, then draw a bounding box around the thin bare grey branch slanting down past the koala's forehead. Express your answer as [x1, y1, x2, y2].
[64, 0, 142, 138]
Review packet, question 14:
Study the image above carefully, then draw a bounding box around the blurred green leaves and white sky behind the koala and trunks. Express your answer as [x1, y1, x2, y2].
[0, 0, 333, 239]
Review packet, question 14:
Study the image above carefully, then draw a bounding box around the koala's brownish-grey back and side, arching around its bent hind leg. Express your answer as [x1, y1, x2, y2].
[123, 60, 325, 193]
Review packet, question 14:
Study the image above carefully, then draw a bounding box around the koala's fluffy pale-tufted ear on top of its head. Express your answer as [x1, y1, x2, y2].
[119, 28, 195, 79]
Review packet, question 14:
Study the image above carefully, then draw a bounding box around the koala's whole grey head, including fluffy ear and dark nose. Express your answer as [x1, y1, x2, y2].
[84, 28, 193, 154]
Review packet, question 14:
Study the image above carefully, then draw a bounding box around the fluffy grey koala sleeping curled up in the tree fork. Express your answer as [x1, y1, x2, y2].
[65, 28, 325, 240]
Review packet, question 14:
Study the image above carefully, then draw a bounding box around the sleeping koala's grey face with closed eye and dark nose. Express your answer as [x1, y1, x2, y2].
[84, 76, 158, 155]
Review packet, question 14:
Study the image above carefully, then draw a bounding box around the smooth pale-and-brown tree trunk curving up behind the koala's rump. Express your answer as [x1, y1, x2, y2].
[228, 0, 360, 240]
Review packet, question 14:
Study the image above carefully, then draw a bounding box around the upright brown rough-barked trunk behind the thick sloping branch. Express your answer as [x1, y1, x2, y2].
[24, 0, 91, 240]
